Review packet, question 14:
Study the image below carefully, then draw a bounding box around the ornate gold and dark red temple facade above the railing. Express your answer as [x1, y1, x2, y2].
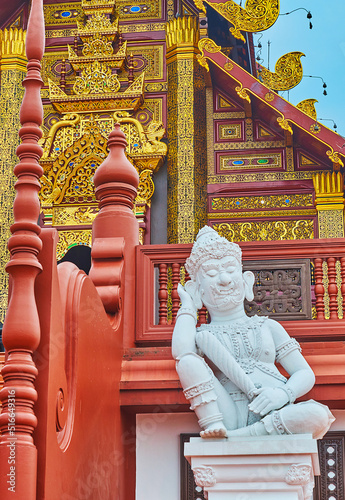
[1, 0, 344, 310]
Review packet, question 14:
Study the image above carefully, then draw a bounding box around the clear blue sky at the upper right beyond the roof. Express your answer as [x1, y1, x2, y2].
[250, 0, 345, 136]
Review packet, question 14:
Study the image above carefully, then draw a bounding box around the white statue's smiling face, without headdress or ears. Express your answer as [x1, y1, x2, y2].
[198, 256, 245, 311]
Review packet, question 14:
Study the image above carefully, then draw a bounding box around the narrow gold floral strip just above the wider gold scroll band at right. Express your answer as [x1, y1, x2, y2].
[212, 193, 314, 210]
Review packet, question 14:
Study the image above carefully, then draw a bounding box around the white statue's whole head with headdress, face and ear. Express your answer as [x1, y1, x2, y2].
[185, 226, 254, 312]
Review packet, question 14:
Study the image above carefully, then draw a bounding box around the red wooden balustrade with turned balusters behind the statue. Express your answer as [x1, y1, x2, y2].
[136, 239, 345, 345]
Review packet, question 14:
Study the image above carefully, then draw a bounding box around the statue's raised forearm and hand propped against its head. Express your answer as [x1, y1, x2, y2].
[171, 284, 197, 359]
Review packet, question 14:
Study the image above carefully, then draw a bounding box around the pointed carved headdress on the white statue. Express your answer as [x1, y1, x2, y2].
[185, 226, 242, 281]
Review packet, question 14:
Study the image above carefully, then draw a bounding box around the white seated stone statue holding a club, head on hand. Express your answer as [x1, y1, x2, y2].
[172, 226, 334, 439]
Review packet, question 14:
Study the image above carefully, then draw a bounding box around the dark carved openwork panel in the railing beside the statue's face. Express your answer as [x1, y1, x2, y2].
[243, 259, 312, 320]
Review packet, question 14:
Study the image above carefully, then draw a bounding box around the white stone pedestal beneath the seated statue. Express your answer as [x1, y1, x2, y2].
[184, 434, 320, 500]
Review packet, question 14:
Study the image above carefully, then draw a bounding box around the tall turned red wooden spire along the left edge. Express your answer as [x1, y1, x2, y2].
[0, 0, 45, 500]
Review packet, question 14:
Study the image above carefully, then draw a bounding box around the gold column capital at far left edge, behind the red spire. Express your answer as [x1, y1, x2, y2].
[0, 28, 27, 71]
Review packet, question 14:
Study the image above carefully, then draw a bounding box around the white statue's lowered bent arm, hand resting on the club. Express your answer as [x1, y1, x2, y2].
[249, 320, 315, 416]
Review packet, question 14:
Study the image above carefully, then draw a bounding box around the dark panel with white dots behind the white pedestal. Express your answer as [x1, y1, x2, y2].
[180, 431, 345, 500]
